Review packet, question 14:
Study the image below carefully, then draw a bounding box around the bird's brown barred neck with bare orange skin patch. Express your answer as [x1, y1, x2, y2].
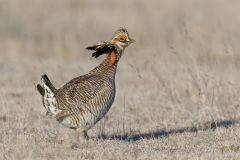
[90, 51, 121, 76]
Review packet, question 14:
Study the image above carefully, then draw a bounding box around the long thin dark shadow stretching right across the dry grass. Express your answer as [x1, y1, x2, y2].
[98, 119, 240, 142]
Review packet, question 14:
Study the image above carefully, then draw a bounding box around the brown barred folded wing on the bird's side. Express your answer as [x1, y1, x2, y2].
[56, 75, 110, 112]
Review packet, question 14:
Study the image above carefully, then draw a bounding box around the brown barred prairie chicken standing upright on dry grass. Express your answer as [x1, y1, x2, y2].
[36, 27, 135, 140]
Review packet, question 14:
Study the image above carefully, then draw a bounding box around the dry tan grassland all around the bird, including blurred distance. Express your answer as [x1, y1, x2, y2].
[0, 0, 240, 160]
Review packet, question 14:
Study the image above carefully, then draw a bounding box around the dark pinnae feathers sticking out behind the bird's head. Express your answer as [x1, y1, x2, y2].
[86, 41, 116, 58]
